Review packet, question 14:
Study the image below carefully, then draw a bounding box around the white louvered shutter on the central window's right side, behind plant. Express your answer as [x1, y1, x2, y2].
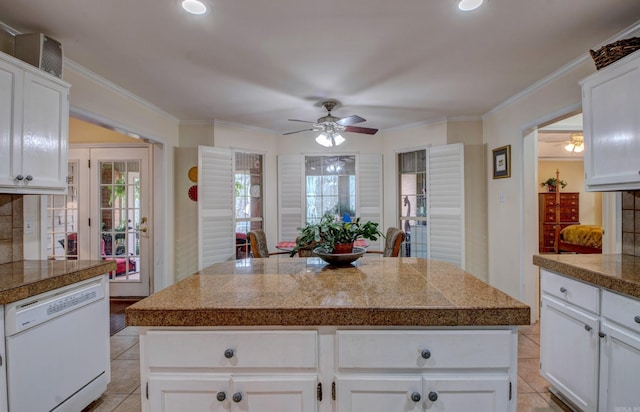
[357, 154, 386, 250]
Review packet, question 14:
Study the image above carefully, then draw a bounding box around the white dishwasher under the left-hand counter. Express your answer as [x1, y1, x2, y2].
[5, 275, 111, 412]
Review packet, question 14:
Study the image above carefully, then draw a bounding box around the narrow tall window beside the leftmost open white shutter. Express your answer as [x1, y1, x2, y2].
[234, 152, 263, 258]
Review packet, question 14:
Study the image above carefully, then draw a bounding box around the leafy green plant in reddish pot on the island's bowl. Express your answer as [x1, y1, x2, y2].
[291, 213, 383, 256]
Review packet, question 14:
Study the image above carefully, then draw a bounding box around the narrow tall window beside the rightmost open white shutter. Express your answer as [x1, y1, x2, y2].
[398, 150, 427, 258]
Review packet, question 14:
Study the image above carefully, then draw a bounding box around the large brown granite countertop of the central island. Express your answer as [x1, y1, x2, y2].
[126, 255, 530, 326]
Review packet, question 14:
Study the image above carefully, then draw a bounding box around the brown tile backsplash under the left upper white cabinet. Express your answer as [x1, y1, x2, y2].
[0, 194, 24, 264]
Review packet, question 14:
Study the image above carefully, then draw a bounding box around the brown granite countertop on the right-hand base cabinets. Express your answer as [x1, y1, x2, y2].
[533, 254, 640, 299]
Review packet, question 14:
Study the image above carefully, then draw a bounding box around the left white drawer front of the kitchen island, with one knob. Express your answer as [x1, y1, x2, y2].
[140, 330, 318, 369]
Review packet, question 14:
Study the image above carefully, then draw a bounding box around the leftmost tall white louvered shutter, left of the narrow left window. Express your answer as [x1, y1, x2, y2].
[198, 146, 235, 270]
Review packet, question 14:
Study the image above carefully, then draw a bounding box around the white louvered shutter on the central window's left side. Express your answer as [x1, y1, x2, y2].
[278, 155, 306, 241]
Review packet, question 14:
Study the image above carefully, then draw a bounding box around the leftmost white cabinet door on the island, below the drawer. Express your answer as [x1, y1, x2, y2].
[148, 374, 231, 412]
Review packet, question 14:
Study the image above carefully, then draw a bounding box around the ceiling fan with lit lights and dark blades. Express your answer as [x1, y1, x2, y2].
[283, 100, 378, 147]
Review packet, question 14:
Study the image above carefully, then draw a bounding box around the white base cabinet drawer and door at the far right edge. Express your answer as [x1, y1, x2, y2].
[599, 291, 640, 411]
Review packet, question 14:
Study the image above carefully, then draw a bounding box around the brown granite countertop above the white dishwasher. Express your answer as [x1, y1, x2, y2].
[0, 260, 116, 305]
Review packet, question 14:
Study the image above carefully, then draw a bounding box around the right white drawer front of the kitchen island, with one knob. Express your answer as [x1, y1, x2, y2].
[336, 330, 515, 369]
